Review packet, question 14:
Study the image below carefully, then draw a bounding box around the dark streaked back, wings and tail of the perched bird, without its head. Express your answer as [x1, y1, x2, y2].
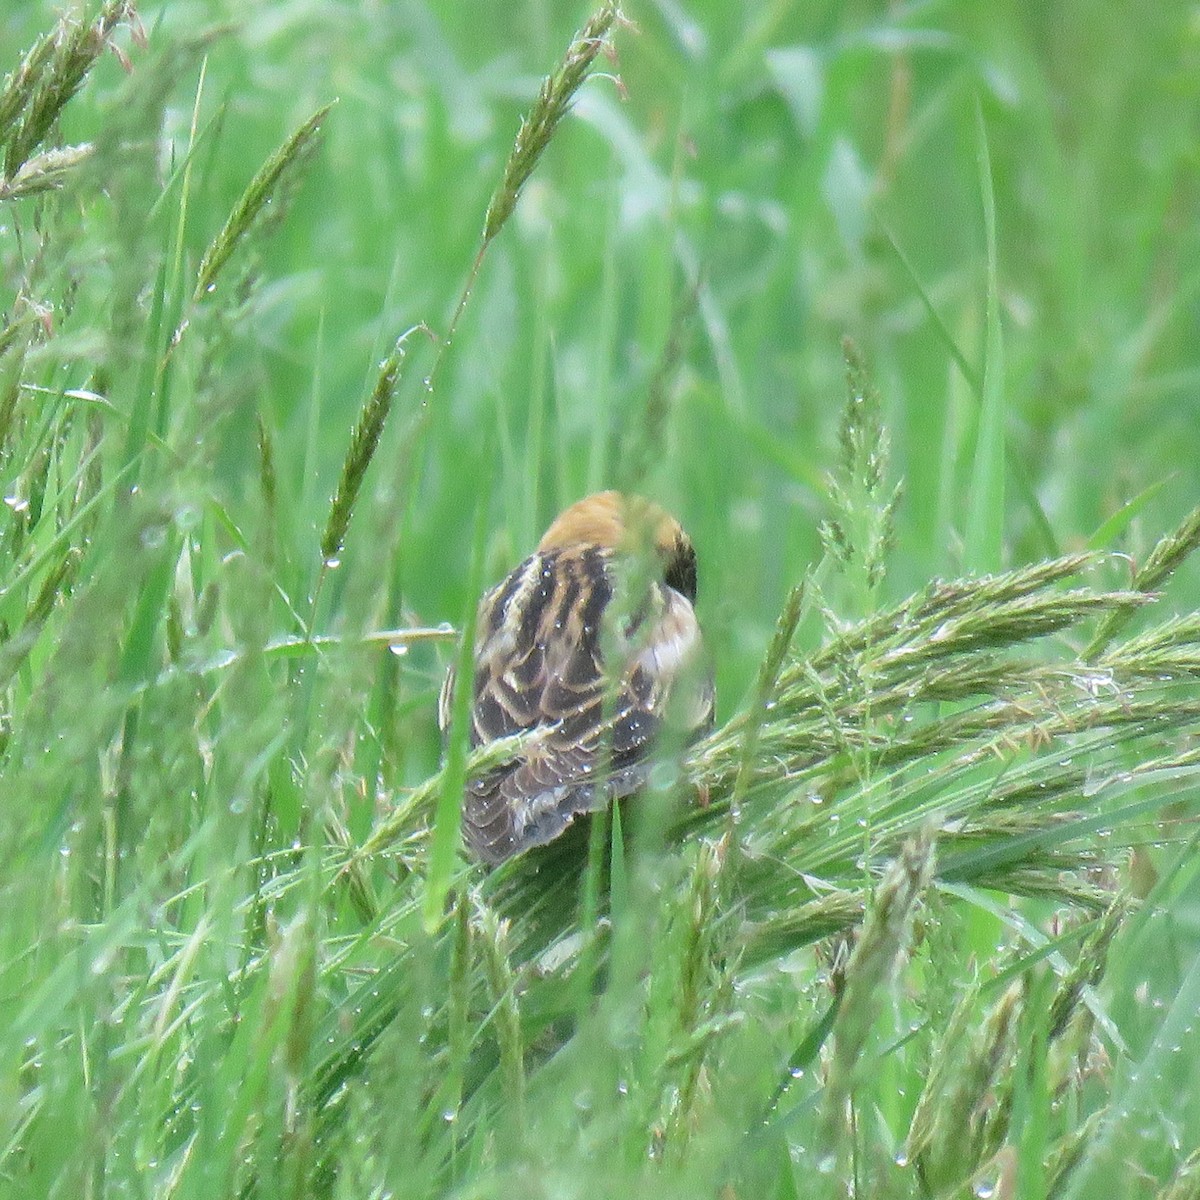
[451, 548, 713, 862]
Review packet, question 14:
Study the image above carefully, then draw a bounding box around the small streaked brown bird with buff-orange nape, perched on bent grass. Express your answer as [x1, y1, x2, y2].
[438, 491, 715, 865]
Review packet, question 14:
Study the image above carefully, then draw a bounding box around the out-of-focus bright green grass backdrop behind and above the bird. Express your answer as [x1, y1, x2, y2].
[9, 0, 1200, 706]
